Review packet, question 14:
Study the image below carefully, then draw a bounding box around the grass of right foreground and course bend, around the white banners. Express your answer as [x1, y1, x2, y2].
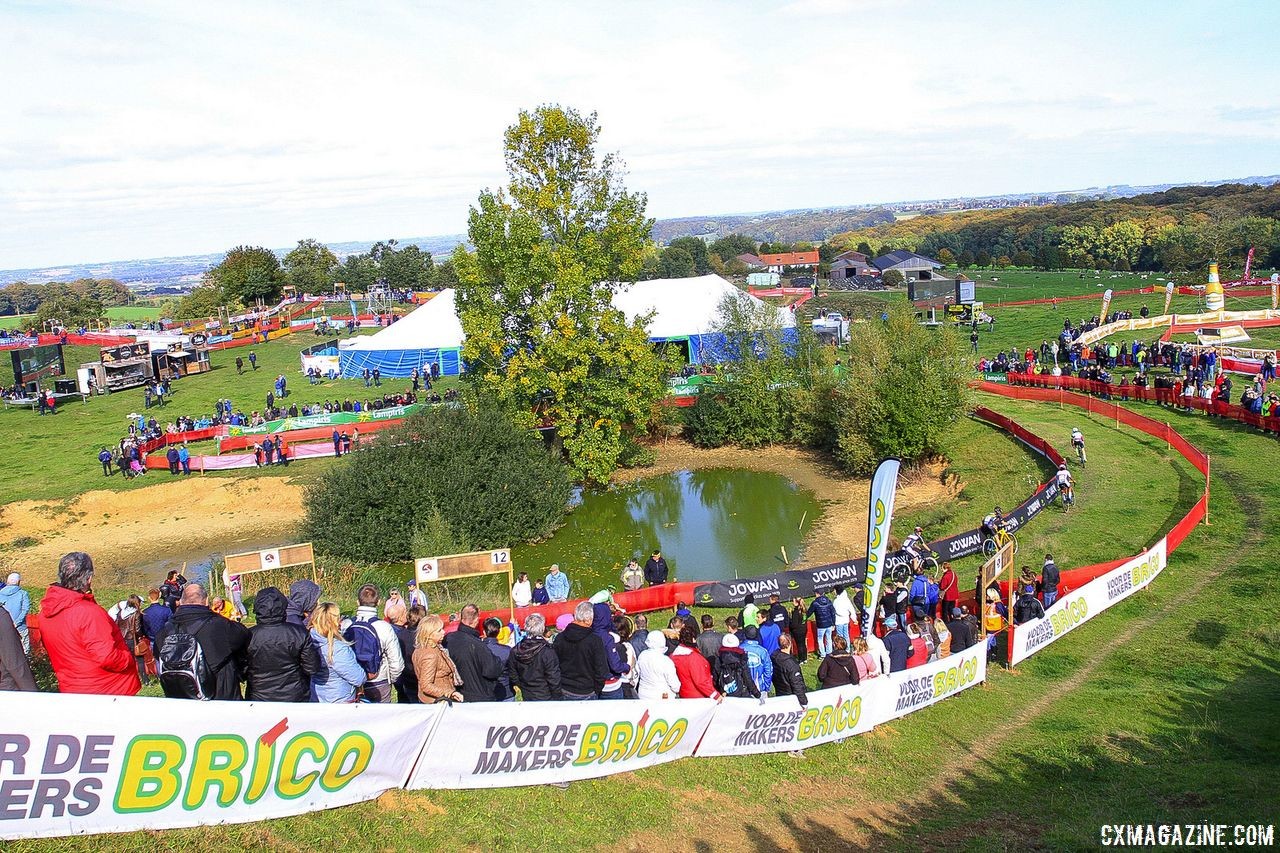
[9, 398, 1280, 850]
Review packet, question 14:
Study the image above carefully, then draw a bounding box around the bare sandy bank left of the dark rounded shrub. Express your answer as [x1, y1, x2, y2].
[0, 474, 302, 585]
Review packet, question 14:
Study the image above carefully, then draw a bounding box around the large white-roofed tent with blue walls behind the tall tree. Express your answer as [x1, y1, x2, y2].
[339, 275, 795, 377]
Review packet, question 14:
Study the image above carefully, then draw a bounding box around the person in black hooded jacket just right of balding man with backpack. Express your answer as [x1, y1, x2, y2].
[244, 587, 321, 702]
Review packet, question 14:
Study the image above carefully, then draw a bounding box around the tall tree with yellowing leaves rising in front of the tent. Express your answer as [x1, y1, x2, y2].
[453, 106, 666, 482]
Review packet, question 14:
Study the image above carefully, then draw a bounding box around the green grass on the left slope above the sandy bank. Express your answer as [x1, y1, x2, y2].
[0, 333, 457, 502]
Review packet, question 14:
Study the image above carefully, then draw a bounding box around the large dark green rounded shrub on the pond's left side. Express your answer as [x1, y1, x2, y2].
[305, 407, 571, 561]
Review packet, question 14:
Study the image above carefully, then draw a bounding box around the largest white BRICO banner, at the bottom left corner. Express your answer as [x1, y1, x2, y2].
[0, 693, 442, 839]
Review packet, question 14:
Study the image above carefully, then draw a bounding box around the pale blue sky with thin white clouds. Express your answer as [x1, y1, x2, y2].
[0, 0, 1280, 269]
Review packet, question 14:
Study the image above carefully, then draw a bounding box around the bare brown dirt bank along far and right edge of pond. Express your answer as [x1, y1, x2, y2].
[614, 441, 963, 564]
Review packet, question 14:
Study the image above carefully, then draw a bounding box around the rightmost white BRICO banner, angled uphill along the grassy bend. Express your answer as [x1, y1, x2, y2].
[1012, 539, 1169, 665]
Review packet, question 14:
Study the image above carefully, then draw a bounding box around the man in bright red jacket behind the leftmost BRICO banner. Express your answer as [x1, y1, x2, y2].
[40, 551, 142, 695]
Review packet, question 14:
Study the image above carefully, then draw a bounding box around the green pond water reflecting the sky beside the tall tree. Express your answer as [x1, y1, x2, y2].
[512, 469, 822, 597]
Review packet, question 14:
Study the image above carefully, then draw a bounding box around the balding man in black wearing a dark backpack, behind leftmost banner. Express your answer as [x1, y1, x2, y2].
[155, 584, 250, 699]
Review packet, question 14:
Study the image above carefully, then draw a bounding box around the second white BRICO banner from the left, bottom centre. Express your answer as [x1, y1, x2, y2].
[407, 699, 716, 789]
